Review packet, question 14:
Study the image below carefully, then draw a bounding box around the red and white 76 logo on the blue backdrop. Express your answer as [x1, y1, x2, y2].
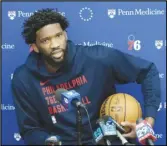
[128, 34, 141, 51]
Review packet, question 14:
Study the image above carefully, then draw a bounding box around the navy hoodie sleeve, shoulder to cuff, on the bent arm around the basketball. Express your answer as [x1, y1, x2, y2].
[86, 46, 161, 119]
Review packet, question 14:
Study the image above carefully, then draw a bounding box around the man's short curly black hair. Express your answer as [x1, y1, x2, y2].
[22, 8, 69, 44]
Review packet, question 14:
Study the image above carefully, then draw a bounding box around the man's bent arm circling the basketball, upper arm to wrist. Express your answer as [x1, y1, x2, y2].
[108, 50, 161, 126]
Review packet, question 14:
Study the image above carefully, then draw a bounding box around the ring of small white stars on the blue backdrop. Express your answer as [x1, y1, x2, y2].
[79, 7, 93, 21]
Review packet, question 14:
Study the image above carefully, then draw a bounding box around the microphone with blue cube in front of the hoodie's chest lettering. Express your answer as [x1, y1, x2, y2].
[55, 88, 85, 109]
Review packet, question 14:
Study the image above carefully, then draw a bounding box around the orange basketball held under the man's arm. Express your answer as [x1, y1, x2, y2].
[100, 93, 142, 132]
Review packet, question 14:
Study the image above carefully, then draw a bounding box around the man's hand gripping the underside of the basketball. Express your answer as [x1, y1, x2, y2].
[121, 121, 136, 138]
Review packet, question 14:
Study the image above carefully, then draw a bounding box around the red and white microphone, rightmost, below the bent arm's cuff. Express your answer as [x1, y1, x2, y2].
[136, 118, 156, 145]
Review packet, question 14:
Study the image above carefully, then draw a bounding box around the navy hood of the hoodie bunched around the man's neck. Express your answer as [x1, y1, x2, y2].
[25, 40, 76, 77]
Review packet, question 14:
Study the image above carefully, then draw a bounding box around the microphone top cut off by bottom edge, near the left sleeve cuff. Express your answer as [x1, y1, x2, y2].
[45, 136, 62, 146]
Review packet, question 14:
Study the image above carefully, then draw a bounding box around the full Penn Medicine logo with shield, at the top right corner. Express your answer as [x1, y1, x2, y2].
[107, 8, 165, 19]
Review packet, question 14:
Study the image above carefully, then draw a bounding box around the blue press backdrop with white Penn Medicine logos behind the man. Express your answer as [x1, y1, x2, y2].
[1, 2, 166, 145]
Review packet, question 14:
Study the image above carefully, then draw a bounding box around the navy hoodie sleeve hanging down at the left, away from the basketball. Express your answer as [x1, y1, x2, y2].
[12, 71, 49, 145]
